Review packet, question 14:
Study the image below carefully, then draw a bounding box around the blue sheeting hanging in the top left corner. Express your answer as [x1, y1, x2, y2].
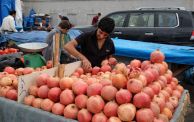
[0, 0, 15, 26]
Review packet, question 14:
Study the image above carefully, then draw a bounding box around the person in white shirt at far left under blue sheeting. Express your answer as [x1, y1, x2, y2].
[0, 10, 18, 33]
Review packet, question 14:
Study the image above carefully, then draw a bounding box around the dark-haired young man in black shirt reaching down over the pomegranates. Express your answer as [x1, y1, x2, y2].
[64, 17, 115, 71]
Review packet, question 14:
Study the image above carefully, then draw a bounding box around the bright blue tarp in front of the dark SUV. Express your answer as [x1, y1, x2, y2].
[113, 39, 194, 65]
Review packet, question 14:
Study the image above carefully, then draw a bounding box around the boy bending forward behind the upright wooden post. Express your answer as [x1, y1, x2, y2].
[43, 21, 70, 61]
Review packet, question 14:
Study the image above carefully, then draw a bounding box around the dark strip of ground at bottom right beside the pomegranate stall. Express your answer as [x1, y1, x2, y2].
[181, 82, 194, 122]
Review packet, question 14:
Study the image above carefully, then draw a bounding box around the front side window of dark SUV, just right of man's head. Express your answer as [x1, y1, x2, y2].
[109, 13, 127, 27]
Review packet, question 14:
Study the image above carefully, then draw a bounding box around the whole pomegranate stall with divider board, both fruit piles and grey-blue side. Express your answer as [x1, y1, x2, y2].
[0, 50, 189, 122]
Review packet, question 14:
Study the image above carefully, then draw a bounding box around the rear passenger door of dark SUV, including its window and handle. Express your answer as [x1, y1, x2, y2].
[124, 11, 155, 42]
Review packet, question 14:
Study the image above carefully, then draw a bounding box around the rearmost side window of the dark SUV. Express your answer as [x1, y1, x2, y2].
[158, 13, 178, 27]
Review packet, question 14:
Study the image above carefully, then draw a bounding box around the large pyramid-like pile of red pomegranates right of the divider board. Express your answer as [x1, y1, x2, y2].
[24, 50, 184, 122]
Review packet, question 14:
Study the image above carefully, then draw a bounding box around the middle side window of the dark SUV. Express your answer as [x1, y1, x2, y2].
[128, 13, 154, 27]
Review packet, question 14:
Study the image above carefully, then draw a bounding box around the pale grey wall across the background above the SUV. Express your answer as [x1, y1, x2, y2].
[24, 0, 194, 25]
